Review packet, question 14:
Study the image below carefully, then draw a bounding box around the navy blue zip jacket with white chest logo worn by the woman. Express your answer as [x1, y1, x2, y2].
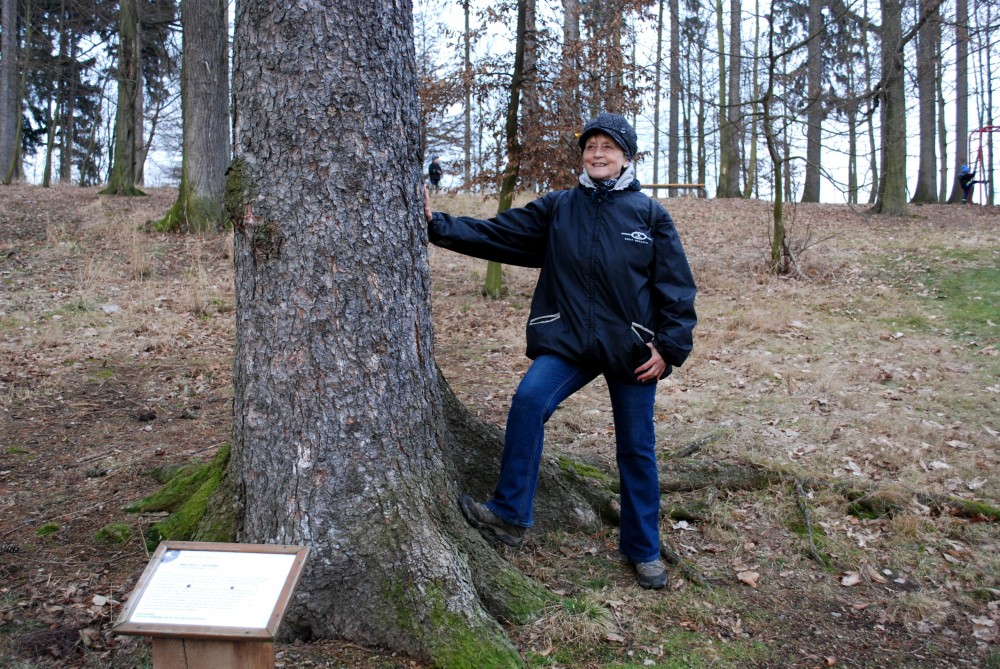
[428, 181, 697, 383]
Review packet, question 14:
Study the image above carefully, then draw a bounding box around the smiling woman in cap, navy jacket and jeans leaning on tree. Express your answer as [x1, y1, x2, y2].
[424, 113, 696, 588]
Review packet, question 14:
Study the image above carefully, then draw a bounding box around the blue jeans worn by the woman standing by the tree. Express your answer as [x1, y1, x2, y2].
[486, 355, 660, 562]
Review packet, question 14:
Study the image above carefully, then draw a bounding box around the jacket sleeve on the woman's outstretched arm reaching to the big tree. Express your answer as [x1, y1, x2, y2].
[427, 194, 552, 267]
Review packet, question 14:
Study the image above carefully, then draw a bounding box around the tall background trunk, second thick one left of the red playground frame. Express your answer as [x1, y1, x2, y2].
[911, 0, 941, 204]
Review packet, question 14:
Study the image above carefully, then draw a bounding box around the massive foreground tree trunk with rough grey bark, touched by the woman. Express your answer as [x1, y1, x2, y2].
[227, 0, 600, 667]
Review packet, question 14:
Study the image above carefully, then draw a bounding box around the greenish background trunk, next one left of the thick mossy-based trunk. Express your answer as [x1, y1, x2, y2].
[101, 0, 142, 195]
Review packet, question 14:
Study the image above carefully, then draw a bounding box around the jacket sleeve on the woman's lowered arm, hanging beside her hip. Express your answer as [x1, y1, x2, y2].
[653, 203, 698, 366]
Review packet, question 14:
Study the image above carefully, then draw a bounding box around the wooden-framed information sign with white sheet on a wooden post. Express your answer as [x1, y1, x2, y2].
[112, 541, 309, 669]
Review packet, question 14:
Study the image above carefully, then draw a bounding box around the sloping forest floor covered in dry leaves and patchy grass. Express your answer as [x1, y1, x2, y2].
[0, 186, 1000, 669]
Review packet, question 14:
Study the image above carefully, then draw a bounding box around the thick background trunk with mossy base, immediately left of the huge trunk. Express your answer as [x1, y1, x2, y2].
[161, 0, 231, 232]
